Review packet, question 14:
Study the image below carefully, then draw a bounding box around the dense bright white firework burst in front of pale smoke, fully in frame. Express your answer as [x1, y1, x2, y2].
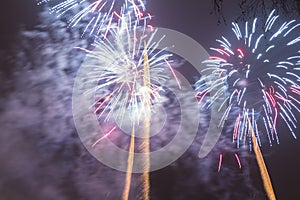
[78, 14, 171, 123]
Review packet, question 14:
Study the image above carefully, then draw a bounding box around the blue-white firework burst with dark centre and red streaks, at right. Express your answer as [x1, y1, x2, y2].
[196, 10, 300, 148]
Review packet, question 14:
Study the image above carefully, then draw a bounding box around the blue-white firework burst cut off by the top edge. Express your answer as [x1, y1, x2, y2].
[38, 0, 151, 35]
